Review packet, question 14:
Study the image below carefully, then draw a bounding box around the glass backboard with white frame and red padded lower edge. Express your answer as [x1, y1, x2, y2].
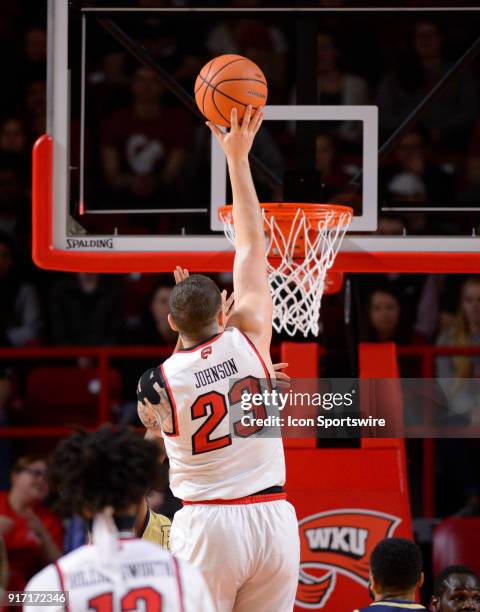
[33, 0, 480, 272]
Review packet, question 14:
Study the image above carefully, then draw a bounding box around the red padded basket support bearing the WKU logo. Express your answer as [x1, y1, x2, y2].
[282, 344, 412, 612]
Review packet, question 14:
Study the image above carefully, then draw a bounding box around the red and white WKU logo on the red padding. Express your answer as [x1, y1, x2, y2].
[295, 508, 401, 609]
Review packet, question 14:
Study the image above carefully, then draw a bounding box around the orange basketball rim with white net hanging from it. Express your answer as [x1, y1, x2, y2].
[219, 203, 353, 336]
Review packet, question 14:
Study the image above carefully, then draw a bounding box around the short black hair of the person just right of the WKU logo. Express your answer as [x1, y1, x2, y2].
[370, 538, 423, 590]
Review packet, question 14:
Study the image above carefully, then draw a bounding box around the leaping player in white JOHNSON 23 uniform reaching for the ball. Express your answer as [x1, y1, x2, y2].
[138, 108, 299, 612]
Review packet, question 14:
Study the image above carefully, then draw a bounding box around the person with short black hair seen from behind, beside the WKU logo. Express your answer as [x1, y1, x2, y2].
[355, 538, 426, 612]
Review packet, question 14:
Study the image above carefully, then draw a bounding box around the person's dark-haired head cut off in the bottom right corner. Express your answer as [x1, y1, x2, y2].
[430, 565, 480, 612]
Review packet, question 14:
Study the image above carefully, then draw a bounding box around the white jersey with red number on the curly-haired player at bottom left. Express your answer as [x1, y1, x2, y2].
[23, 538, 215, 612]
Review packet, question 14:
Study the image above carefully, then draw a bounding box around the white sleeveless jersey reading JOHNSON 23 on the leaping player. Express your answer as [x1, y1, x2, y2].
[138, 327, 285, 501]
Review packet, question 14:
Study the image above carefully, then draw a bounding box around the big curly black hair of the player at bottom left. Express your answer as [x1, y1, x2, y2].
[50, 425, 163, 515]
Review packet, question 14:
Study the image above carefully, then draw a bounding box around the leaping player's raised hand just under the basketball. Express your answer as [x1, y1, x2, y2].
[206, 104, 263, 160]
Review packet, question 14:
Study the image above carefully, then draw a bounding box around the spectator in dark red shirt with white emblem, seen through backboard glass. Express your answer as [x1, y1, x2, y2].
[101, 68, 191, 206]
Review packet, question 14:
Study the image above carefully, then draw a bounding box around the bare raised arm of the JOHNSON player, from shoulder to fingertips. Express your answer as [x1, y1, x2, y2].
[207, 106, 272, 354]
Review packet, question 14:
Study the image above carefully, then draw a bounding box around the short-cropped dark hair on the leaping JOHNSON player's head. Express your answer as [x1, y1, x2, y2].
[169, 274, 222, 340]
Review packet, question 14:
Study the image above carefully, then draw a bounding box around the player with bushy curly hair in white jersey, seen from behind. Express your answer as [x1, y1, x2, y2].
[24, 427, 215, 612]
